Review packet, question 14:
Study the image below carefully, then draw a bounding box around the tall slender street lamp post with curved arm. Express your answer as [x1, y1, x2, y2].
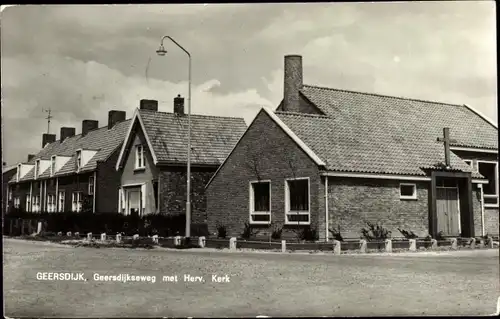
[156, 35, 191, 238]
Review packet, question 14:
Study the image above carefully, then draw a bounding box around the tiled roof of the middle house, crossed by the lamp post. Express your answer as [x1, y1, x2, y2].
[139, 110, 246, 165]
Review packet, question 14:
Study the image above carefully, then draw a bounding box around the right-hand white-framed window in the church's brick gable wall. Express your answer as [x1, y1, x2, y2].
[285, 177, 311, 225]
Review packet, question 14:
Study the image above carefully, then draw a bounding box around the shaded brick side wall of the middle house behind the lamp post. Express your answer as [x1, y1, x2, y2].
[159, 167, 216, 224]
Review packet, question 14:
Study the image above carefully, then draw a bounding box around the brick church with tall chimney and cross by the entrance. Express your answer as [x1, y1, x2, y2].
[207, 56, 499, 240]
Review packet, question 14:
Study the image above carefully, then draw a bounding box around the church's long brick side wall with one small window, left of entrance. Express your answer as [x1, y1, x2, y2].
[328, 178, 430, 238]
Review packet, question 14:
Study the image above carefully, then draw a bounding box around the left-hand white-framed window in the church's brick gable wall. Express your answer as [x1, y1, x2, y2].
[249, 180, 271, 224]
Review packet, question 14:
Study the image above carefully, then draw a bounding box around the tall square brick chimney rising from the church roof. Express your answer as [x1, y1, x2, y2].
[283, 55, 303, 112]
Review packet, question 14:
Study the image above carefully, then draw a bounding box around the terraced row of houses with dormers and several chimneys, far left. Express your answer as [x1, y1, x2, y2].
[8, 110, 129, 212]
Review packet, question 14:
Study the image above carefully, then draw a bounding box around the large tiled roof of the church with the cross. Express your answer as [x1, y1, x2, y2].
[276, 86, 498, 177]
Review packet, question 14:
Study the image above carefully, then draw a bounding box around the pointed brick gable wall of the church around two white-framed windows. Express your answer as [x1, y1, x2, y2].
[207, 112, 324, 239]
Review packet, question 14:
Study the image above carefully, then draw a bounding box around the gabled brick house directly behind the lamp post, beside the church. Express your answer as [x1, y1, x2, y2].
[116, 96, 246, 223]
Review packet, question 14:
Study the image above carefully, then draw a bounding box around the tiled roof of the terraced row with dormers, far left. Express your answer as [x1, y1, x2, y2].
[11, 120, 130, 182]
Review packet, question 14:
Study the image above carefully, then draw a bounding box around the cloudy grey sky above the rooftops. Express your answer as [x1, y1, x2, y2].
[1, 2, 497, 165]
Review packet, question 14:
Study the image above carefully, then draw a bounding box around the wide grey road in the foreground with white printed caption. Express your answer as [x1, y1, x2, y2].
[4, 239, 500, 317]
